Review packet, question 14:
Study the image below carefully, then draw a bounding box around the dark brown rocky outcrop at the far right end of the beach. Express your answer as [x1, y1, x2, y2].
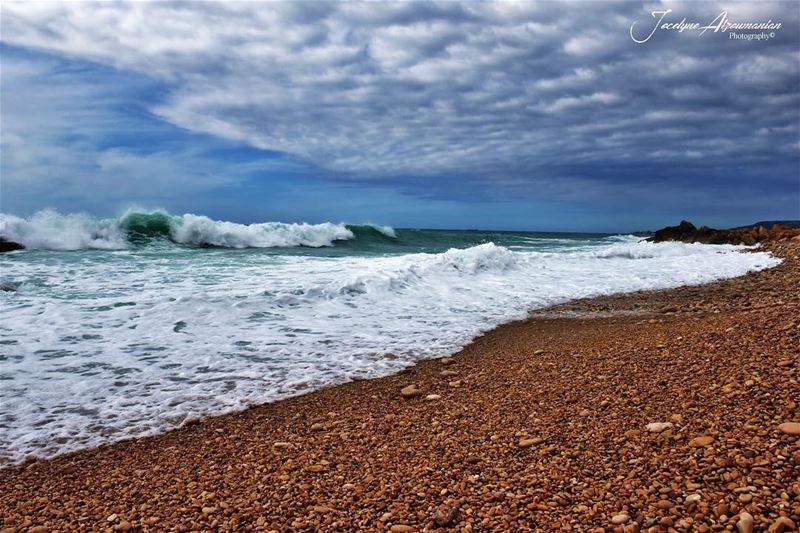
[647, 220, 800, 245]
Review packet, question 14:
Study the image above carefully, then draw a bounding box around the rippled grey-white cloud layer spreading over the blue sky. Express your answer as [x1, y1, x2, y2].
[2, 2, 800, 222]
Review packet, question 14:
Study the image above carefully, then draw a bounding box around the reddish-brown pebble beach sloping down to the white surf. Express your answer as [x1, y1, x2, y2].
[0, 242, 800, 532]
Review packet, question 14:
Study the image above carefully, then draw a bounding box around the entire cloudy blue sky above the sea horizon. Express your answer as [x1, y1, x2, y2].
[0, 1, 800, 231]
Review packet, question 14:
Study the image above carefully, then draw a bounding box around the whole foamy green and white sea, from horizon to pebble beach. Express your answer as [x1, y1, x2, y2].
[0, 209, 779, 465]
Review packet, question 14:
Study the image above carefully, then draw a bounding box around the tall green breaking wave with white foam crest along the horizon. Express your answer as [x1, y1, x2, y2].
[0, 210, 396, 250]
